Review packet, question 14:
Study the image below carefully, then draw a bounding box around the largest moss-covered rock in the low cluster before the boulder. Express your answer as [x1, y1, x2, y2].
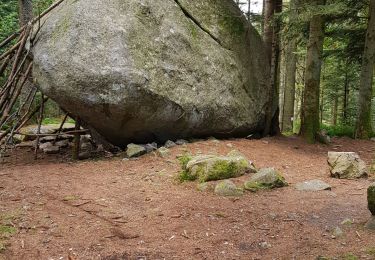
[180, 155, 253, 182]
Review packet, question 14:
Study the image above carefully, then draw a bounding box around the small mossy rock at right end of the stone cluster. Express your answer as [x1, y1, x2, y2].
[244, 168, 288, 192]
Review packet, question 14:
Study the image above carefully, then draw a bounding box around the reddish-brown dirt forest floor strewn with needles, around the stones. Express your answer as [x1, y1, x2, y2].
[0, 137, 375, 260]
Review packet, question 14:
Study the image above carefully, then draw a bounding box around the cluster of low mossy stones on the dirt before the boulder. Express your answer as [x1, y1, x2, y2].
[179, 151, 288, 196]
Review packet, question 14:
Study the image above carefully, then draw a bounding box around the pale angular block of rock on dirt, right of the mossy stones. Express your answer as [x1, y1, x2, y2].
[328, 152, 368, 179]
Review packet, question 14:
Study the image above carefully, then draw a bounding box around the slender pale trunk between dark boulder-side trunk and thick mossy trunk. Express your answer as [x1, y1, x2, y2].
[282, 0, 297, 132]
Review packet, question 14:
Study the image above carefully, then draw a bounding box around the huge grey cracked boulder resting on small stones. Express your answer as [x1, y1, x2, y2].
[33, 0, 269, 147]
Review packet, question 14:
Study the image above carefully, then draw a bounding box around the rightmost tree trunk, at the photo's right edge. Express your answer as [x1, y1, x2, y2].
[355, 0, 375, 139]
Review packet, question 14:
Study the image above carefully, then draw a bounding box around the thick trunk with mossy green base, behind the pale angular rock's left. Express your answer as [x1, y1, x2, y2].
[300, 0, 325, 143]
